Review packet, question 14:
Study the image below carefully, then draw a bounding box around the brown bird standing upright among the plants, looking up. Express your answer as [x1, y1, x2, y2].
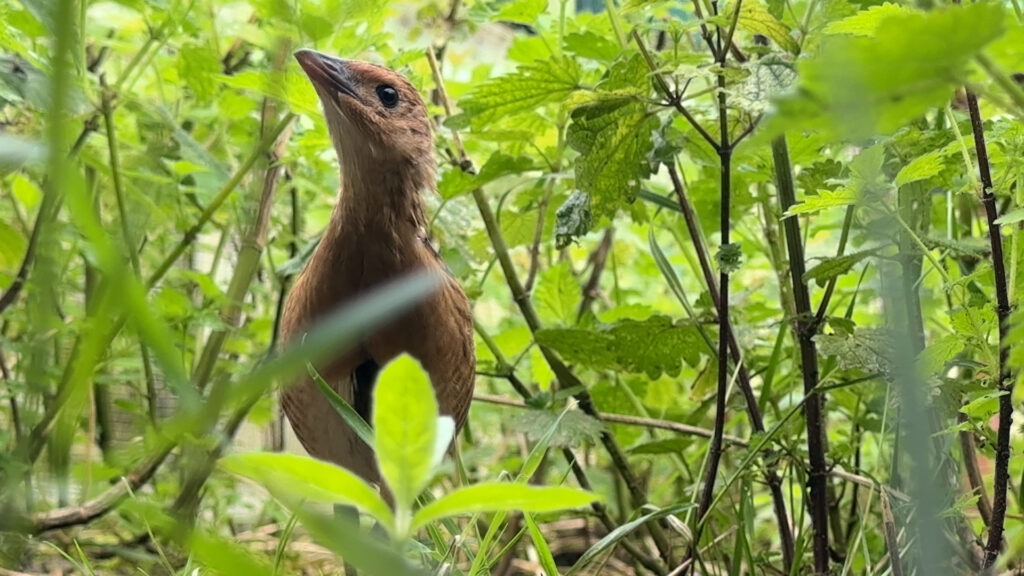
[281, 50, 475, 484]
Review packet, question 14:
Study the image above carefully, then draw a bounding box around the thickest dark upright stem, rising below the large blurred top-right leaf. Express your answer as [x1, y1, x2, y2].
[771, 136, 828, 574]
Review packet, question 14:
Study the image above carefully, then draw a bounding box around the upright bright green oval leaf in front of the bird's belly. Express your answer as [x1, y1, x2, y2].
[373, 355, 437, 509]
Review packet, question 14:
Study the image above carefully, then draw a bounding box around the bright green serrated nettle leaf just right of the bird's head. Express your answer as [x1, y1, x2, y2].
[450, 58, 582, 127]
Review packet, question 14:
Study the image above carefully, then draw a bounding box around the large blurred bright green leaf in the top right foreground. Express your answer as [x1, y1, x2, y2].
[768, 3, 1005, 139]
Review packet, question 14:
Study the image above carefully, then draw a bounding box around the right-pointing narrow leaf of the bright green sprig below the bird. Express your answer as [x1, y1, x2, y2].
[413, 482, 600, 530]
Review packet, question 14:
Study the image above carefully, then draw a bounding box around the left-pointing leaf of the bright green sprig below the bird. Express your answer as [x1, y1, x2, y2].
[219, 452, 394, 527]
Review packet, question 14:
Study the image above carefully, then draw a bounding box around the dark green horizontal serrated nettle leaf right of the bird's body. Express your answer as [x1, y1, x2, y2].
[537, 316, 706, 378]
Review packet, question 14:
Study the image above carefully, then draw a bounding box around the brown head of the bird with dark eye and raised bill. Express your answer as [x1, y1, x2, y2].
[295, 50, 433, 177]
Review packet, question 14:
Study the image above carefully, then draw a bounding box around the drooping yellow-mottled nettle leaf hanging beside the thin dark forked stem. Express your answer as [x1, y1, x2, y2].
[566, 54, 659, 217]
